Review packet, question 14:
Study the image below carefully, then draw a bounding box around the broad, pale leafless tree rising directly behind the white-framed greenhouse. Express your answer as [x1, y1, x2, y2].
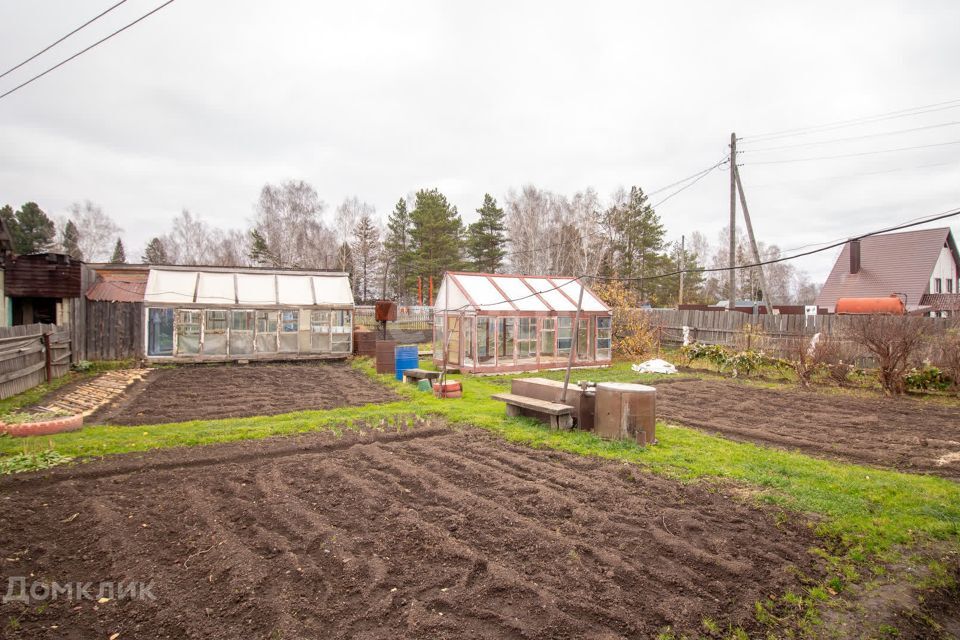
[253, 180, 337, 269]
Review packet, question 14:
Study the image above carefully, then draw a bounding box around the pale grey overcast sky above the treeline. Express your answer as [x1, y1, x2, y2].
[0, 0, 960, 280]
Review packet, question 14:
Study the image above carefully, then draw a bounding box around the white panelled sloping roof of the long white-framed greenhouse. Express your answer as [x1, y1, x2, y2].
[144, 267, 353, 307]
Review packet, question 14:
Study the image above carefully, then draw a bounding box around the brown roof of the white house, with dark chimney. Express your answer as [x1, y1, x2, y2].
[817, 227, 957, 311]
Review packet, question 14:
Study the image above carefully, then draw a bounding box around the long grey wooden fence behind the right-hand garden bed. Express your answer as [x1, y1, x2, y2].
[645, 309, 951, 351]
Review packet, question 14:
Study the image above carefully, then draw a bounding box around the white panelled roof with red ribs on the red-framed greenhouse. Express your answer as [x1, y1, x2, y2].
[434, 271, 610, 313]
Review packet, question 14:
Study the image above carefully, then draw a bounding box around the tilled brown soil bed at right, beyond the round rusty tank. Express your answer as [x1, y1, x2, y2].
[657, 379, 960, 479]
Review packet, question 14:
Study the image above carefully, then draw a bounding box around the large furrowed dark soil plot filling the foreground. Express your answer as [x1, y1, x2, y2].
[0, 424, 819, 640]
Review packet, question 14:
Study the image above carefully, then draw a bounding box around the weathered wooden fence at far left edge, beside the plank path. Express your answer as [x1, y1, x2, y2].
[0, 324, 71, 398]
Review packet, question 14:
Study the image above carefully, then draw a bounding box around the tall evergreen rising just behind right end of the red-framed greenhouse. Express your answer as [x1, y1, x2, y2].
[607, 187, 669, 302]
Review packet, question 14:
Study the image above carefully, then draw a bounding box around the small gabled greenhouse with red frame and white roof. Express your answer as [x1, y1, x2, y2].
[433, 272, 613, 373]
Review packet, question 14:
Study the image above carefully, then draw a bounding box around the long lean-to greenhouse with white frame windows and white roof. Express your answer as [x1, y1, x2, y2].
[143, 266, 354, 362]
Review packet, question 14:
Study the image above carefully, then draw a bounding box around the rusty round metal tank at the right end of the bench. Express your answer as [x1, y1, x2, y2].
[594, 382, 657, 445]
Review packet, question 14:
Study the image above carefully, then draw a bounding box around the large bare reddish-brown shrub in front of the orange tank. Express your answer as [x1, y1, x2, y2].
[848, 315, 930, 394]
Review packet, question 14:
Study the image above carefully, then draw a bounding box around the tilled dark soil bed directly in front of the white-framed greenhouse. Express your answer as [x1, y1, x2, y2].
[88, 363, 398, 425]
